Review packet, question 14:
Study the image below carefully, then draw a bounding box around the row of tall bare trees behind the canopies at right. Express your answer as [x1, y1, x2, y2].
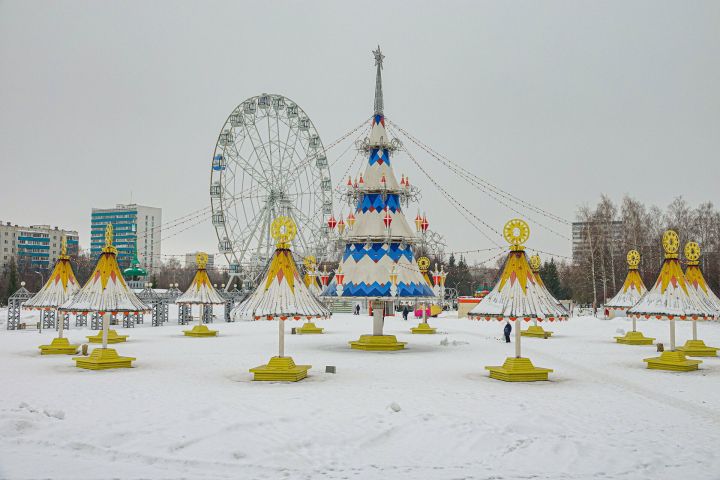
[572, 195, 720, 305]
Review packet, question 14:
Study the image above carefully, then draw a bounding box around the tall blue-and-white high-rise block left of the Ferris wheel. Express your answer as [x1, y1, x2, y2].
[90, 203, 162, 271]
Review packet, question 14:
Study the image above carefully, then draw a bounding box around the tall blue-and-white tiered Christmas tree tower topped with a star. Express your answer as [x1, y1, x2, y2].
[323, 47, 435, 351]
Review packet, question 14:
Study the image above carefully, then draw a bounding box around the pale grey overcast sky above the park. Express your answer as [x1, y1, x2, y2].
[0, 0, 720, 266]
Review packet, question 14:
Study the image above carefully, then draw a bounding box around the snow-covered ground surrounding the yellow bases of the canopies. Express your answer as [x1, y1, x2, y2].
[0, 311, 720, 480]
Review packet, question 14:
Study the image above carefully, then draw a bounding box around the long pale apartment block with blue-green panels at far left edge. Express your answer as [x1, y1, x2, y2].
[0, 222, 79, 271]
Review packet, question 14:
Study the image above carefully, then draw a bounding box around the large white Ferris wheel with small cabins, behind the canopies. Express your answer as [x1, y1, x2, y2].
[210, 93, 333, 285]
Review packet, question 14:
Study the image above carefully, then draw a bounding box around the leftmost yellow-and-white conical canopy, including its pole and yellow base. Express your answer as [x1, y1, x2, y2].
[23, 237, 80, 355]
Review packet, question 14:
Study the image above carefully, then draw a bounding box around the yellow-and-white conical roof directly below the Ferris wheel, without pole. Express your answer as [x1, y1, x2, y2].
[230, 217, 331, 320]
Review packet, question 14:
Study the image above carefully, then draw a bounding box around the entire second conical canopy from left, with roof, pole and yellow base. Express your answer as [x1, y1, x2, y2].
[58, 224, 151, 370]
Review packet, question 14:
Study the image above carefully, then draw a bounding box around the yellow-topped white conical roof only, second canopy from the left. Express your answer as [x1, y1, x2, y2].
[59, 224, 150, 313]
